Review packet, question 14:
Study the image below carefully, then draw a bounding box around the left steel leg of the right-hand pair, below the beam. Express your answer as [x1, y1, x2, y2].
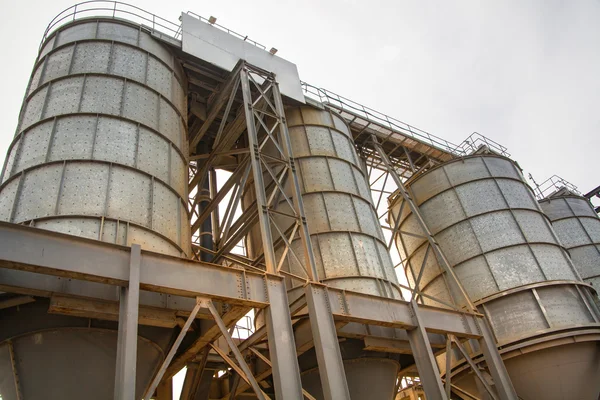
[406, 298, 448, 400]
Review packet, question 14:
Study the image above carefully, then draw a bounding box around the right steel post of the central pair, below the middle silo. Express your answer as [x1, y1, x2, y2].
[304, 284, 350, 400]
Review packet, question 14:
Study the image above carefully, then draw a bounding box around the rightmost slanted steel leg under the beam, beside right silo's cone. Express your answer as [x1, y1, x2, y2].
[477, 318, 518, 400]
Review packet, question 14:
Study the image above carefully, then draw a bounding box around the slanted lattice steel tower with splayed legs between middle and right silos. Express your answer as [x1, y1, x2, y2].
[371, 135, 518, 400]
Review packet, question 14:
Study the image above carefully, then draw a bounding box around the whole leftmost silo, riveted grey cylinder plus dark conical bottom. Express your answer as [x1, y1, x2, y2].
[0, 18, 190, 400]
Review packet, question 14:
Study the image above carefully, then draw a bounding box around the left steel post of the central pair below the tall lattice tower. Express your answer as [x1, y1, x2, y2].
[265, 276, 302, 400]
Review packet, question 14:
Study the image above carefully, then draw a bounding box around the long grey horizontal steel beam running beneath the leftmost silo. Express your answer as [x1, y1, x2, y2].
[0, 222, 270, 308]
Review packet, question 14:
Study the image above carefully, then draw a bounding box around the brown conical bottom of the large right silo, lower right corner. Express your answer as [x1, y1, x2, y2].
[452, 341, 600, 400]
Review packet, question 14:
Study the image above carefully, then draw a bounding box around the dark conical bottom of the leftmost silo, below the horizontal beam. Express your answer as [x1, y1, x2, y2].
[0, 298, 172, 400]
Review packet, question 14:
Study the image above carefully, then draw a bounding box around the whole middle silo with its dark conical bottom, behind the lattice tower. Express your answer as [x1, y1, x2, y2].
[245, 107, 401, 400]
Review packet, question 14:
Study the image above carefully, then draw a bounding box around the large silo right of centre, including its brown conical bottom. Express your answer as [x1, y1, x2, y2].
[391, 155, 600, 400]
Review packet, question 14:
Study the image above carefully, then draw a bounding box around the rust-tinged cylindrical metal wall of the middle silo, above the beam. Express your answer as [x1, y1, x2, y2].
[278, 107, 402, 299]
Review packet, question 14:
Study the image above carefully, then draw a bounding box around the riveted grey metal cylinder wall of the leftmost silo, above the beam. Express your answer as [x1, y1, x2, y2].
[0, 20, 190, 256]
